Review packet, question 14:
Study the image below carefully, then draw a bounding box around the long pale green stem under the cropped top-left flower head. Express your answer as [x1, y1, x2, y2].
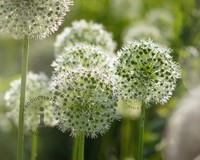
[17, 36, 29, 160]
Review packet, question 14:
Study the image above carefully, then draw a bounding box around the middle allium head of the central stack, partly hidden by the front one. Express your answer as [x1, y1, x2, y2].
[52, 43, 111, 73]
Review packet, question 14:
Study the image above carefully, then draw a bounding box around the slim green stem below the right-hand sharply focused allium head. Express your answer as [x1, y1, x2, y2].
[138, 103, 145, 160]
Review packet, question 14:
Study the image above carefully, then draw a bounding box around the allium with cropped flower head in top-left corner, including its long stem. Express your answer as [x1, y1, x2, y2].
[0, 0, 73, 160]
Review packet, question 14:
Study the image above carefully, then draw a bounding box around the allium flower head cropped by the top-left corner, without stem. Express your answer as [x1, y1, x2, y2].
[0, 0, 73, 39]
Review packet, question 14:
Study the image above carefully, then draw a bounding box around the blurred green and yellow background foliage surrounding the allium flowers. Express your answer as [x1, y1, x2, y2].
[0, 0, 200, 160]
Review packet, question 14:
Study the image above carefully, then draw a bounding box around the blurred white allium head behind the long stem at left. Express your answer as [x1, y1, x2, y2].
[4, 72, 54, 131]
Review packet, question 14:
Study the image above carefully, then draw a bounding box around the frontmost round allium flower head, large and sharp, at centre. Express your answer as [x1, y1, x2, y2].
[51, 68, 118, 138]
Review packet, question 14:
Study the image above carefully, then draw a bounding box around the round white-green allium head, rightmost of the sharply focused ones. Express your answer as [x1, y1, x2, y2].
[115, 40, 180, 104]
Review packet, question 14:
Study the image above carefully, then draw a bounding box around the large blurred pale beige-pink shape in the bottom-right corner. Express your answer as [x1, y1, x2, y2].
[161, 86, 200, 160]
